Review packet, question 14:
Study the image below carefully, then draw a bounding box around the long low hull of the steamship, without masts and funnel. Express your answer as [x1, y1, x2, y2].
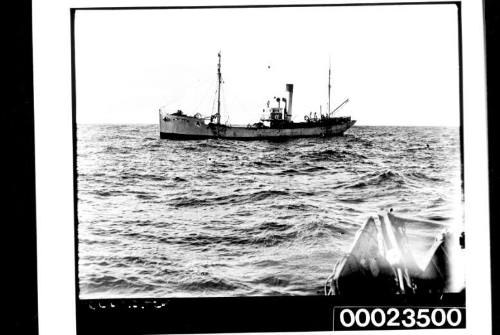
[160, 114, 356, 141]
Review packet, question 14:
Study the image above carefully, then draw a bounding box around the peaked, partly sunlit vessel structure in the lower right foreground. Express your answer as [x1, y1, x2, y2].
[325, 212, 465, 297]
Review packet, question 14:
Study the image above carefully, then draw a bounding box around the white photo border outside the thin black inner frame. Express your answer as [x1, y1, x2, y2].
[33, 0, 491, 335]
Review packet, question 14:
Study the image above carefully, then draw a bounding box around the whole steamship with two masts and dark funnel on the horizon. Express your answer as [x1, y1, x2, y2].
[159, 52, 356, 140]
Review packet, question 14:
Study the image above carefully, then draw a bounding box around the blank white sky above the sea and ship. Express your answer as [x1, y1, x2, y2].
[75, 5, 459, 126]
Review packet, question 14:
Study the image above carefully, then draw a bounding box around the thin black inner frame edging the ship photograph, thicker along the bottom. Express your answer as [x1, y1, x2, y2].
[70, 1, 465, 335]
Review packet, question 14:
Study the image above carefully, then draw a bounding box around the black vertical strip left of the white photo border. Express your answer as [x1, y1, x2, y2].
[8, 0, 38, 334]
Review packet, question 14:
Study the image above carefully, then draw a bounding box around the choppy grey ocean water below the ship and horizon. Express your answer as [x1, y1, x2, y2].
[77, 125, 463, 298]
